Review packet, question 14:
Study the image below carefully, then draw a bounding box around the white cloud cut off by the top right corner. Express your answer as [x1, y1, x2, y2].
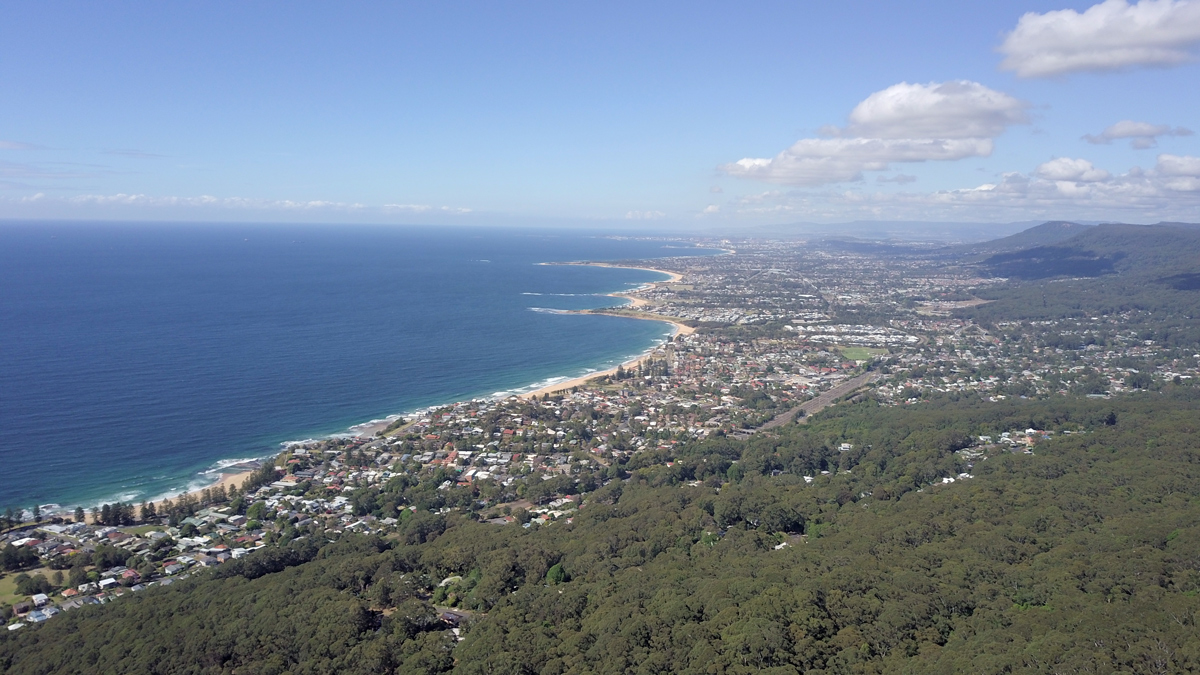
[1000, 0, 1200, 77]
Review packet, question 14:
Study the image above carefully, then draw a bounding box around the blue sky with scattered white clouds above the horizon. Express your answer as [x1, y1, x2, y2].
[0, 0, 1200, 226]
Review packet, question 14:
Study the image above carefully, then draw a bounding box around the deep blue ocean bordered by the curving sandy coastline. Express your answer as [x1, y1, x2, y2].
[0, 223, 701, 508]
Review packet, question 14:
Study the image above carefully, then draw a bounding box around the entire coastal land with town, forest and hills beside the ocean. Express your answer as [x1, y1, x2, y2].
[7, 223, 1200, 675]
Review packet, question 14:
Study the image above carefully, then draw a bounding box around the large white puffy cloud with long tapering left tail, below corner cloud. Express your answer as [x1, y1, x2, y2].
[720, 80, 1028, 185]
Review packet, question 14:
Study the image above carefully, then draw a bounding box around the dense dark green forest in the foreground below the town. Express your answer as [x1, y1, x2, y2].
[0, 388, 1200, 674]
